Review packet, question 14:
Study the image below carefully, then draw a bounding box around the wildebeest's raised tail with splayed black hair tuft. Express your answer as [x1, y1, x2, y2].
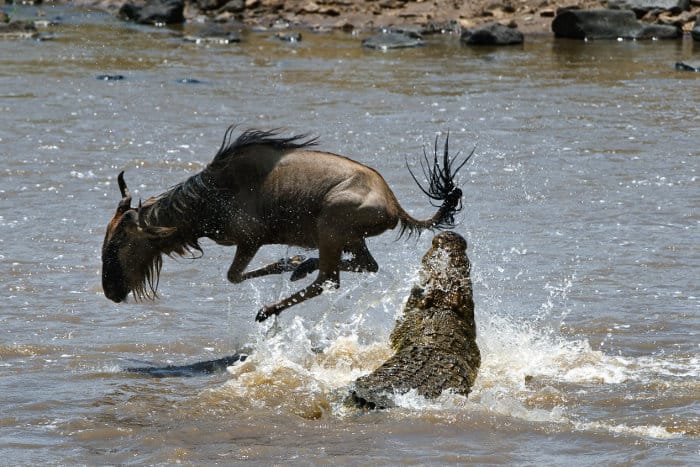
[399, 132, 474, 236]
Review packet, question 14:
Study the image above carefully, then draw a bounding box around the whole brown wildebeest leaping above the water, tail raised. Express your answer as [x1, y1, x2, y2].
[102, 126, 473, 321]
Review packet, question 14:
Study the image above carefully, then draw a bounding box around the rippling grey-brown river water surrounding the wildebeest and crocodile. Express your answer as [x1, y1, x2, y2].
[0, 7, 700, 465]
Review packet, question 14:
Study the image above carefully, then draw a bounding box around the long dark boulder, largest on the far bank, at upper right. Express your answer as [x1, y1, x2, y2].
[552, 9, 682, 40]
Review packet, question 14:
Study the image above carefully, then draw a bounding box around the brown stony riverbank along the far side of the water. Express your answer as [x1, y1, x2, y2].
[9, 0, 700, 33]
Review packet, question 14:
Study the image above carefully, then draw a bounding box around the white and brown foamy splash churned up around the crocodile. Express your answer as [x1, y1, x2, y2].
[215, 278, 698, 439]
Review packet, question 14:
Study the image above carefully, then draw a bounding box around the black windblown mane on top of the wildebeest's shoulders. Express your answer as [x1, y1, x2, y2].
[207, 125, 318, 170]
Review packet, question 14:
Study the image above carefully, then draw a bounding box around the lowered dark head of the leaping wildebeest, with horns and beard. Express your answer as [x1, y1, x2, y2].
[102, 172, 175, 303]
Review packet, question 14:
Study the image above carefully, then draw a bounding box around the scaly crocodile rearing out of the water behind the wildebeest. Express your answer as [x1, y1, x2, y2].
[347, 231, 481, 409]
